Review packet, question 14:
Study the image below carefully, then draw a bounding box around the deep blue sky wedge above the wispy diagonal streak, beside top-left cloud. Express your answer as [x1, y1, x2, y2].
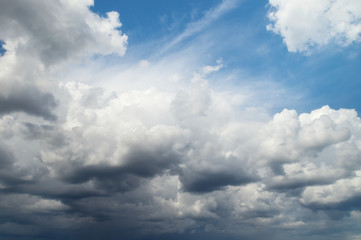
[92, 0, 220, 46]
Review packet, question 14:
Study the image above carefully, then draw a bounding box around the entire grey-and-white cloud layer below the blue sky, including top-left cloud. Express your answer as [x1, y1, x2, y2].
[0, 0, 361, 239]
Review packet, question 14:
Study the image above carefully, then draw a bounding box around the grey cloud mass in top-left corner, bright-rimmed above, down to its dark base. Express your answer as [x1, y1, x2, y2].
[0, 1, 127, 120]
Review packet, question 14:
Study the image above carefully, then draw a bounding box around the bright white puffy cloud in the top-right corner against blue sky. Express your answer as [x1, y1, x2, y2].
[267, 0, 361, 52]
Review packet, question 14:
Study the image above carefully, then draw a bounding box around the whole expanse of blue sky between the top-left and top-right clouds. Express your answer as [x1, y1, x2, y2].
[93, 0, 361, 115]
